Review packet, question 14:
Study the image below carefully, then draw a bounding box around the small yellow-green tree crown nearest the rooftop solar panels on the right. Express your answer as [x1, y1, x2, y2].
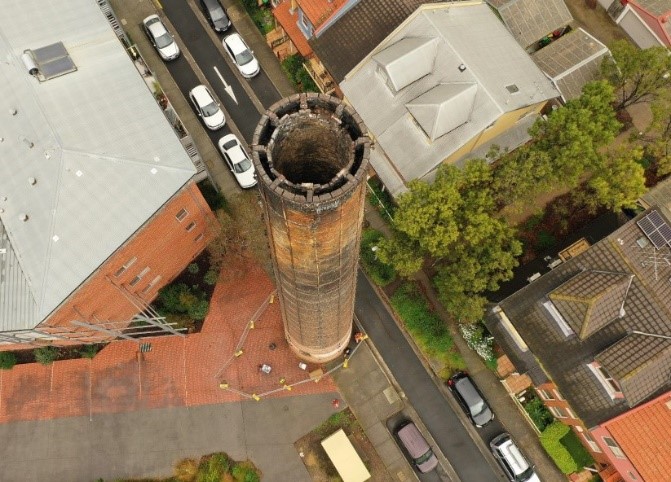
[584, 145, 646, 211]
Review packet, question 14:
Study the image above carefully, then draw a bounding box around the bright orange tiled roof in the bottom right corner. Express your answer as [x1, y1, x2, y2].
[603, 393, 671, 482]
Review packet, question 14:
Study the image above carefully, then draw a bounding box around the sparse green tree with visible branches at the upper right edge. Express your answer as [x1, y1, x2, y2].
[601, 40, 671, 110]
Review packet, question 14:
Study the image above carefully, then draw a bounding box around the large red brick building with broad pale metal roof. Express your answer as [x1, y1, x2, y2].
[0, 0, 214, 349]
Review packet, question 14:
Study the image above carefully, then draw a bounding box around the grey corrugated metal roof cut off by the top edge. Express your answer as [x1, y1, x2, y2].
[487, 0, 573, 48]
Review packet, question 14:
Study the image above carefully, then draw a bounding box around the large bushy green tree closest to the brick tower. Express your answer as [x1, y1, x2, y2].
[378, 159, 522, 321]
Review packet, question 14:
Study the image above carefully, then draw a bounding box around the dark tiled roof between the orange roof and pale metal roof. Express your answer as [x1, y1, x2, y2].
[310, 0, 440, 83]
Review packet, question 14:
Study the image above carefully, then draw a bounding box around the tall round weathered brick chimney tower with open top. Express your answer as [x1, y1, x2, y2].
[253, 94, 370, 363]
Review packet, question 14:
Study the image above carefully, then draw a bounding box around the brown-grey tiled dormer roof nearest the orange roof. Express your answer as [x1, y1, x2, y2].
[596, 333, 671, 407]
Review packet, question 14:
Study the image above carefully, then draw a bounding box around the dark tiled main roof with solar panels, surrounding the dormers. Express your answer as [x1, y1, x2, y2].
[487, 211, 671, 427]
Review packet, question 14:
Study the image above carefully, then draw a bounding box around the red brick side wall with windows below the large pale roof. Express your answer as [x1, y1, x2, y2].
[40, 183, 216, 338]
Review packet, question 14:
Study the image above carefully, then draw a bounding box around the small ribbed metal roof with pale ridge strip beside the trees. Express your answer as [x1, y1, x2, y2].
[531, 28, 610, 101]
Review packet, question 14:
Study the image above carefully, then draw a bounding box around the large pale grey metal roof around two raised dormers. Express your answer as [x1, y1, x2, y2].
[340, 2, 559, 194]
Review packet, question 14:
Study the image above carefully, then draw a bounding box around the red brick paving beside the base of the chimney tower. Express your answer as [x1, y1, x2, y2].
[0, 261, 337, 422]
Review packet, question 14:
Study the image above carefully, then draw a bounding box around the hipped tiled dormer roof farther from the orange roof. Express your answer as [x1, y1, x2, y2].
[548, 271, 633, 340]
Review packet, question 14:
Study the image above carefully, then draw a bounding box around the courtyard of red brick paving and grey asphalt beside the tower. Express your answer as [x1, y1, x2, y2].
[0, 260, 339, 482]
